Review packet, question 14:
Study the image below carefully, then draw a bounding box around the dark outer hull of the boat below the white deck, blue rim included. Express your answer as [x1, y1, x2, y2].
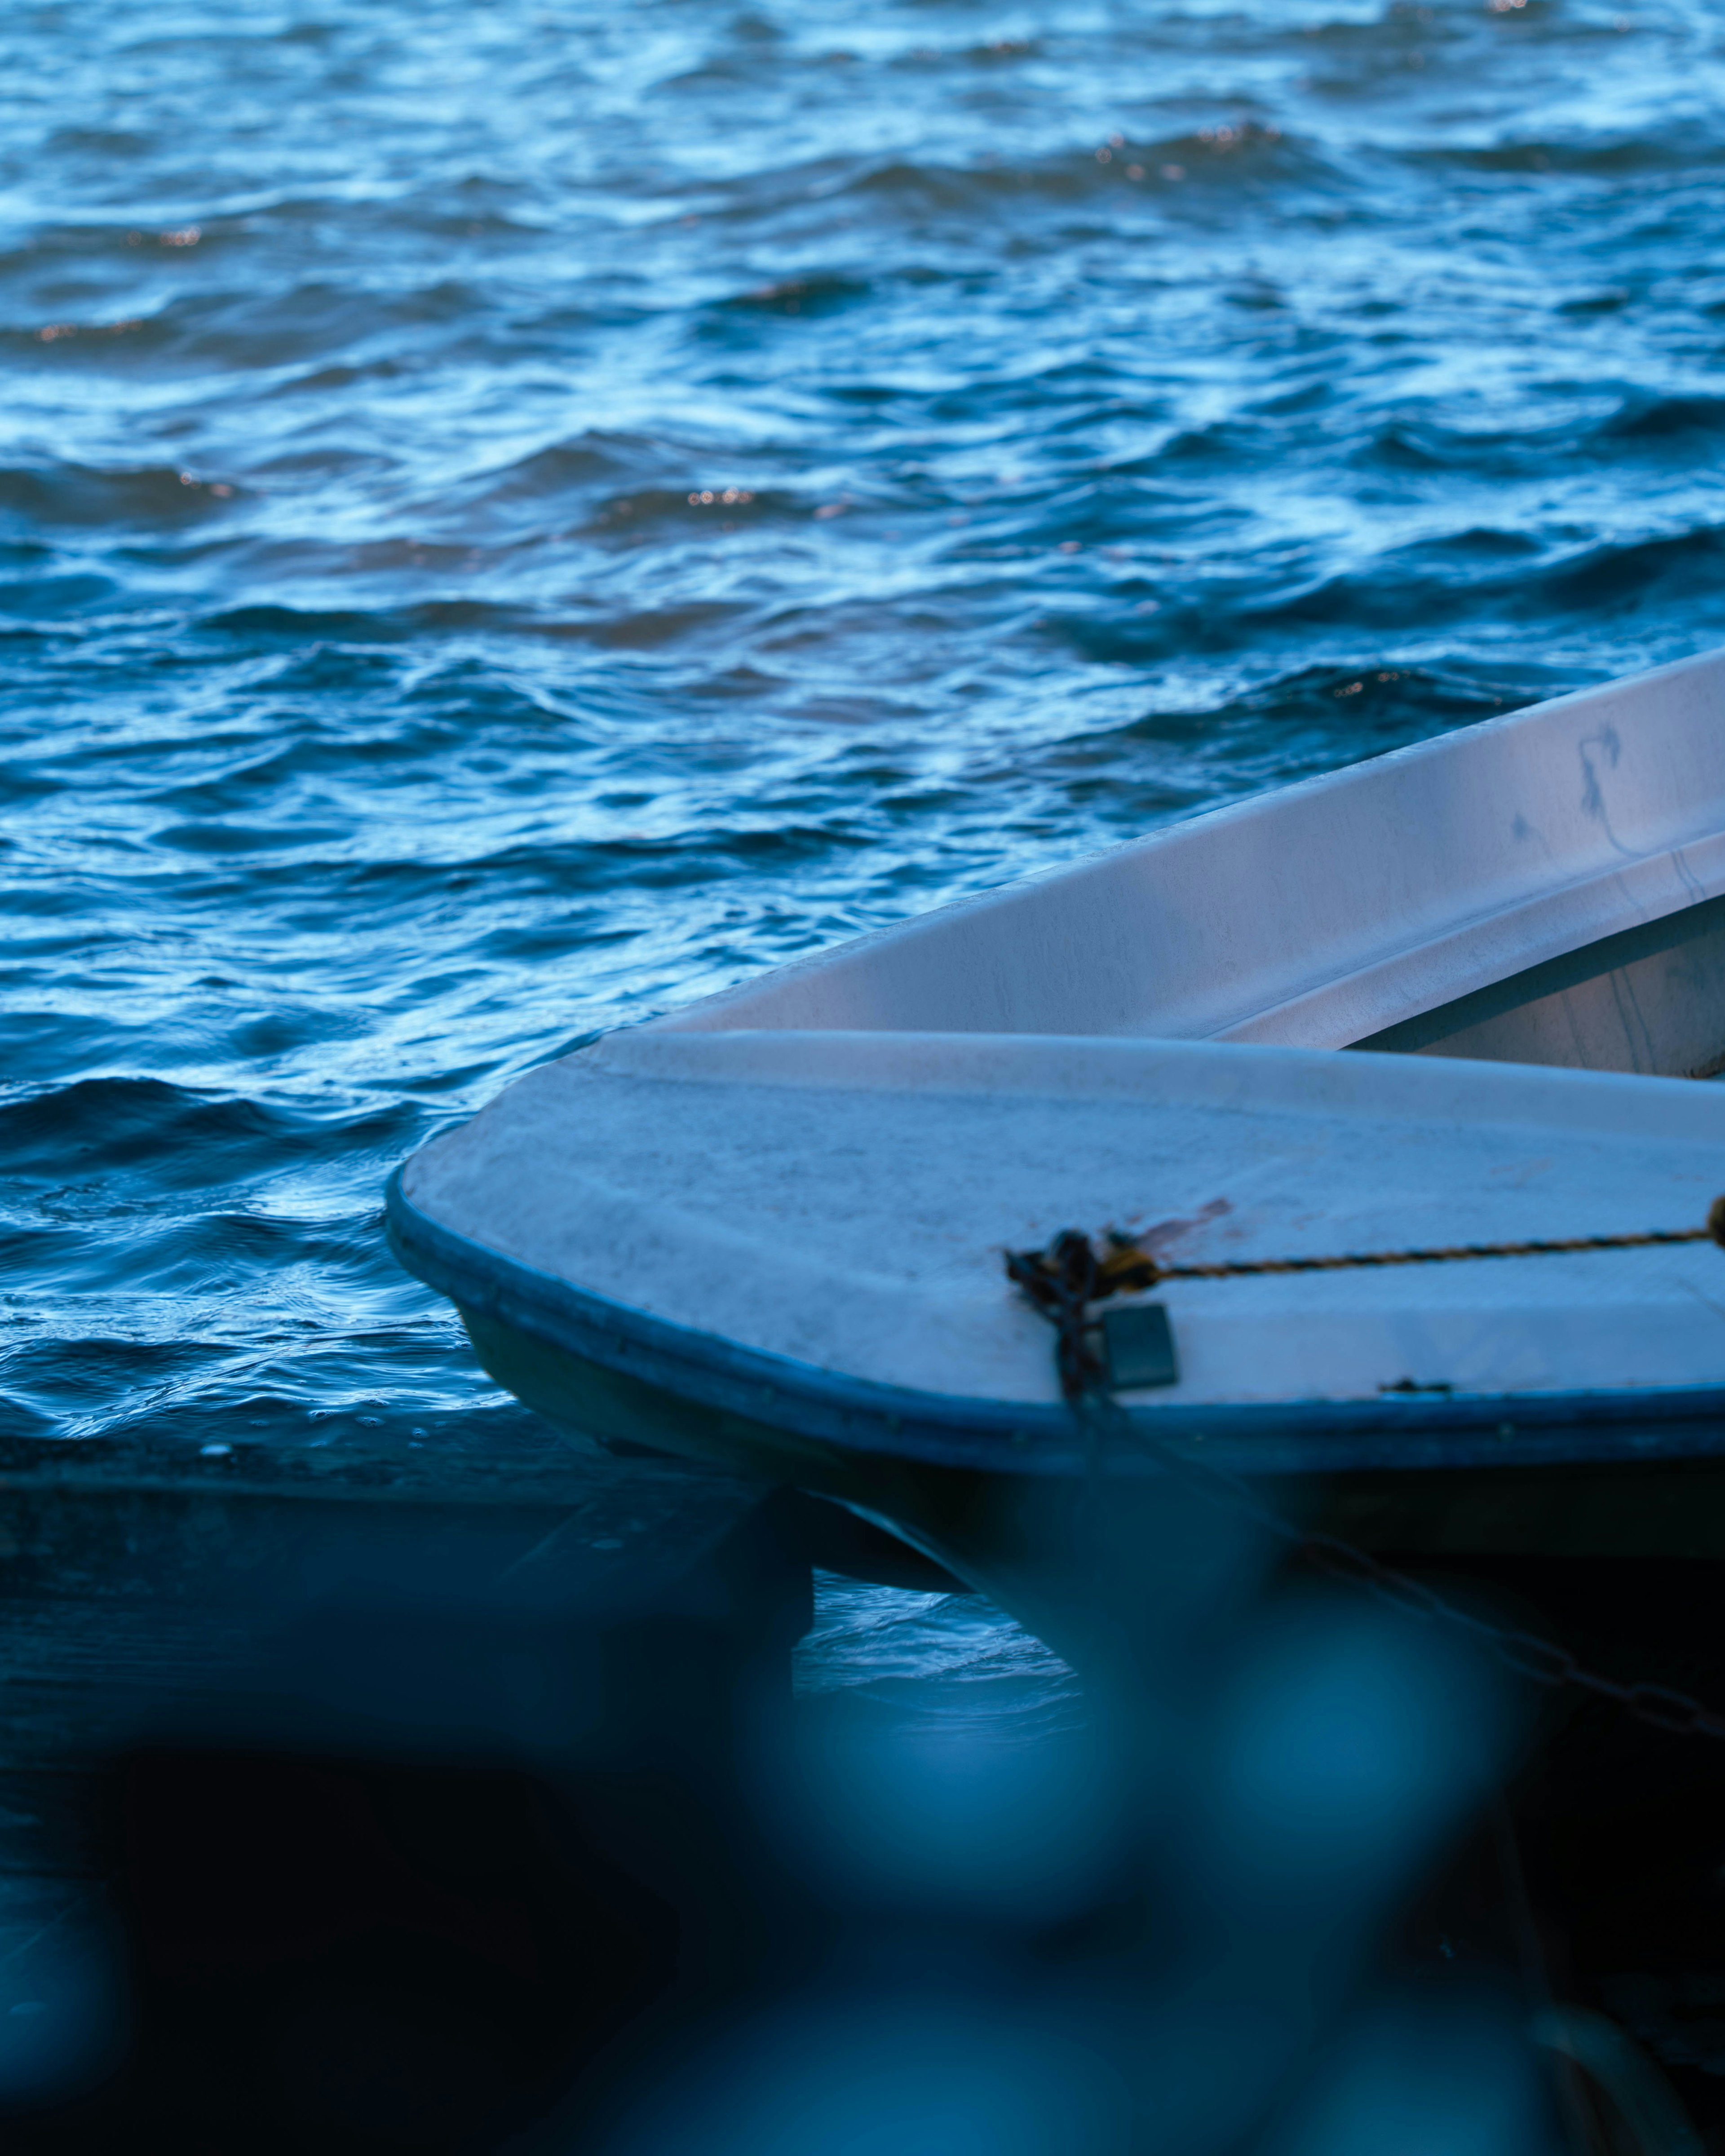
[388, 1180, 1725, 1606]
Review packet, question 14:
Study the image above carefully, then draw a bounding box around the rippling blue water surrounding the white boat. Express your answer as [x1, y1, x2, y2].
[0, 0, 1725, 1707]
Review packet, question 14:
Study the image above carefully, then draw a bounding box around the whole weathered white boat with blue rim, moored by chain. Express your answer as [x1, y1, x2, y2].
[390, 655, 1725, 1578]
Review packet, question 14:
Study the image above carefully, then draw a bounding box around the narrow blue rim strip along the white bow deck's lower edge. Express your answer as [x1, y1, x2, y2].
[384, 1166, 1725, 1475]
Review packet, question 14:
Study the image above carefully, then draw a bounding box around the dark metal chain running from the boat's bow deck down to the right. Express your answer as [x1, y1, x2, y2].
[1007, 1233, 1725, 1738]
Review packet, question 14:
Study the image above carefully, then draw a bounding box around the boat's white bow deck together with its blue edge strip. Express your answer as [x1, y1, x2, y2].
[390, 1030, 1725, 1518]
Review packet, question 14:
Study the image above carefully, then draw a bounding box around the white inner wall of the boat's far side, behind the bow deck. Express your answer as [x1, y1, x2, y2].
[660, 653, 1725, 1074]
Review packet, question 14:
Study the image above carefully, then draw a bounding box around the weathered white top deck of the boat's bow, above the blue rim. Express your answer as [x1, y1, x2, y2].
[405, 1029, 1725, 1408]
